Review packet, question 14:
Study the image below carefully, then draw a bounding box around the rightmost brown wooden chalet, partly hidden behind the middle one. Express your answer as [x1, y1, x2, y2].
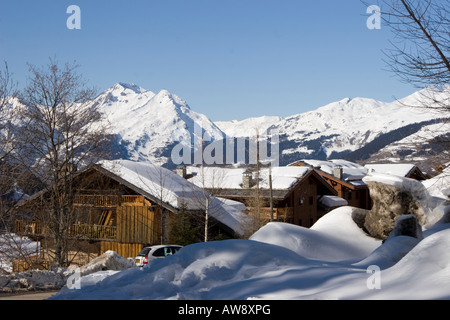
[289, 160, 372, 209]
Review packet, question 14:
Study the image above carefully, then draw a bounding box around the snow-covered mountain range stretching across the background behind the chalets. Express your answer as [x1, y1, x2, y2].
[94, 83, 450, 171]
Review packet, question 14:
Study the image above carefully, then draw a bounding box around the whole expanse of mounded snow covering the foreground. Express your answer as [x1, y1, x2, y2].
[52, 202, 450, 300]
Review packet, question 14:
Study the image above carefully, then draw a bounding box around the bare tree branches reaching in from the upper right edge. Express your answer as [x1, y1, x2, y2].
[368, 0, 450, 172]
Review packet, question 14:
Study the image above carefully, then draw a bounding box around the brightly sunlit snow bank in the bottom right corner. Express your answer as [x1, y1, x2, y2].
[327, 227, 450, 300]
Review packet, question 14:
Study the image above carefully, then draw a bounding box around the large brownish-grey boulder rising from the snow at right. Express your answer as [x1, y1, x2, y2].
[364, 178, 428, 240]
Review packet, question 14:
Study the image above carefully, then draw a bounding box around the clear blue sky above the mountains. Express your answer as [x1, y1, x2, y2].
[0, 0, 416, 121]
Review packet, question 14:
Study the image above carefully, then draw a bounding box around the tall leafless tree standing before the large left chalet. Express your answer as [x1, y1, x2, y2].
[19, 60, 108, 266]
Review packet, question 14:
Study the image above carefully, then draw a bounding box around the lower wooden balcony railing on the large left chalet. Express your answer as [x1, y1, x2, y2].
[14, 220, 117, 241]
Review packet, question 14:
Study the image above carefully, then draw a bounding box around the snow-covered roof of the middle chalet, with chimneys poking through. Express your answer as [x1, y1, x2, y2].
[187, 167, 309, 190]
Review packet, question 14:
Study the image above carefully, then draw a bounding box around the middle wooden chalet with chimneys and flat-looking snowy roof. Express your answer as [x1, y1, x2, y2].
[186, 167, 340, 227]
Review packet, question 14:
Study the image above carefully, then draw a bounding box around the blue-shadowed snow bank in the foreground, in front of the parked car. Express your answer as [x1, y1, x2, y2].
[52, 240, 306, 300]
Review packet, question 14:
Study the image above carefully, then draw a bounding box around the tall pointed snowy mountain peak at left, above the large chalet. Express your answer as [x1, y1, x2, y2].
[94, 82, 223, 163]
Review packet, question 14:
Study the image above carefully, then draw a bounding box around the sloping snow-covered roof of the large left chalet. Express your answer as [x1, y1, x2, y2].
[98, 160, 248, 234]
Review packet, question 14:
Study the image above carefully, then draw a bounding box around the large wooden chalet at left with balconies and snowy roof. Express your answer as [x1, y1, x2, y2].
[15, 160, 248, 263]
